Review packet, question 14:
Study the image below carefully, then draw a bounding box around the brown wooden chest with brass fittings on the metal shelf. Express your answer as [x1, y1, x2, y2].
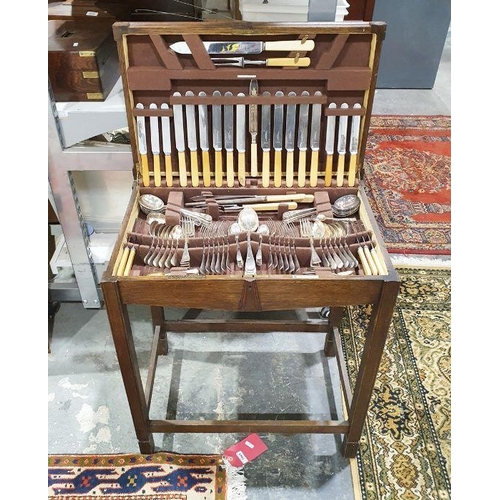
[48, 20, 120, 101]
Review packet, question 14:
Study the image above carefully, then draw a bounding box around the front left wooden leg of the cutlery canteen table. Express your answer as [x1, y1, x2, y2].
[101, 281, 154, 454]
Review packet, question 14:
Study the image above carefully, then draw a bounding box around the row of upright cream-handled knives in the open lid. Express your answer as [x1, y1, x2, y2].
[134, 92, 364, 187]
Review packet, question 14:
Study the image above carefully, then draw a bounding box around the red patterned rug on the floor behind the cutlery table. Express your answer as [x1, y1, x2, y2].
[364, 116, 451, 255]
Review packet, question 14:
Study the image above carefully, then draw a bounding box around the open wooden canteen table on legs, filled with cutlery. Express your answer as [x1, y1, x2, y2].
[101, 21, 399, 457]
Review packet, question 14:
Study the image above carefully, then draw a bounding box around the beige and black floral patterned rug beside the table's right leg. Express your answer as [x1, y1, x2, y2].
[341, 269, 451, 500]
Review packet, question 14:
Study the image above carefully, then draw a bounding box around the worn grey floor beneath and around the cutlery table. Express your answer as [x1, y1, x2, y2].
[48, 18, 451, 500]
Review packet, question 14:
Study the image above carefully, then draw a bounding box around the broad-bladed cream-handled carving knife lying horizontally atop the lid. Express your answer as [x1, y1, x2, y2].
[170, 40, 314, 55]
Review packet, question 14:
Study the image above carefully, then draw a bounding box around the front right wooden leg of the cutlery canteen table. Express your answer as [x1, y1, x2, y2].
[343, 281, 399, 458]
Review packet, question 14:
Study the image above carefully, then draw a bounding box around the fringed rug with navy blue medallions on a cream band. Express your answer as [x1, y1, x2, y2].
[48, 453, 246, 500]
